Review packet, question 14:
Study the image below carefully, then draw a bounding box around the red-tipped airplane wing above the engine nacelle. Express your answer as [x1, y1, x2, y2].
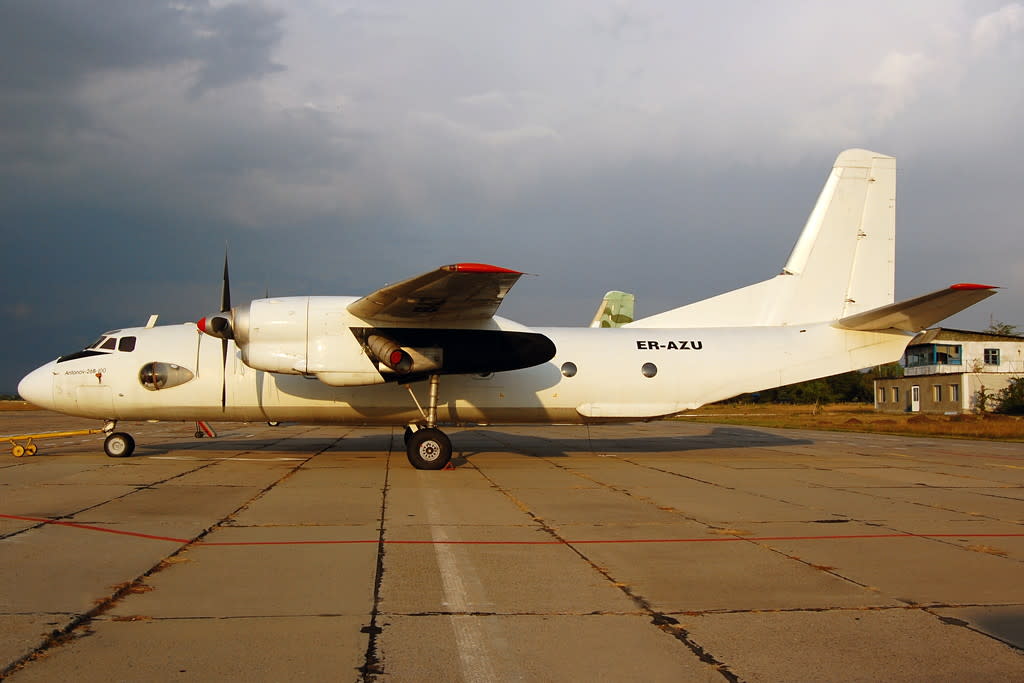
[348, 263, 522, 323]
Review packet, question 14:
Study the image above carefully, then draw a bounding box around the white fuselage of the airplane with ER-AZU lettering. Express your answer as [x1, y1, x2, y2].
[20, 317, 908, 425]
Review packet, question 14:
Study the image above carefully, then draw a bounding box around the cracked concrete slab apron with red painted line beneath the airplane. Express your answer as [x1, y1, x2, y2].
[0, 412, 1024, 682]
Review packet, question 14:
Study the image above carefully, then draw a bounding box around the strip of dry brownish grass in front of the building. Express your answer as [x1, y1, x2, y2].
[681, 403, 1024, 441]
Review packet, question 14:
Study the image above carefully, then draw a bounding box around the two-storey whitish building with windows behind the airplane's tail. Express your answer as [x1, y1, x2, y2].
[874, 328, 1024, 413]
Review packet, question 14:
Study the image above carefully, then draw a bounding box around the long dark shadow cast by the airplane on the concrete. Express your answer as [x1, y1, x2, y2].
[125, 426, 812, 466]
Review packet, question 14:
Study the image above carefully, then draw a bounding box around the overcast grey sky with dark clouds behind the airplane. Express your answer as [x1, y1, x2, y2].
[0, 0, 1024, 392]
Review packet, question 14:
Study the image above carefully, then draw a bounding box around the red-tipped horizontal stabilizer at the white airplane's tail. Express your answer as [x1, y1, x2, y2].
[836, 284, 996, 332]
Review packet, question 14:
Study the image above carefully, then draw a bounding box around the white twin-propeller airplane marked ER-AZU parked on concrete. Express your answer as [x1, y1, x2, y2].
[18, 150, 995, 469]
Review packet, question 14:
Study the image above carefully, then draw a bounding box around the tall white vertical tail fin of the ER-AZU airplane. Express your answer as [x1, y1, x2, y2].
[627, 150, 896, 328]
